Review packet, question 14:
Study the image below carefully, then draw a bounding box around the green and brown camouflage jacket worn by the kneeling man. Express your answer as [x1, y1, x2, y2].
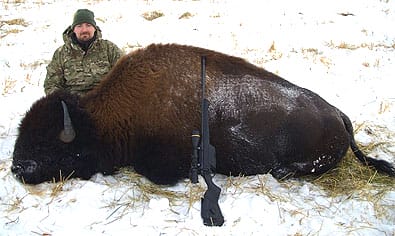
[44, 27, 123, 95]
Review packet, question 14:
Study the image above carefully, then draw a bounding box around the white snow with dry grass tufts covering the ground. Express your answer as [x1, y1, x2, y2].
[0, 0, 395, 236]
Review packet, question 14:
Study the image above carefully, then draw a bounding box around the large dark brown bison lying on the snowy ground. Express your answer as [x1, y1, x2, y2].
[11, 44, 395, 184]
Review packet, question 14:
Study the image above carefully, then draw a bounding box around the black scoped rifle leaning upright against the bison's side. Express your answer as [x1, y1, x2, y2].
[190, 56, 224, 226]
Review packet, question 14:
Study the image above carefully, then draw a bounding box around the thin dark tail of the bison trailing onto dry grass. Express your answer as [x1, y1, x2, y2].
[339, 111, 395, 177]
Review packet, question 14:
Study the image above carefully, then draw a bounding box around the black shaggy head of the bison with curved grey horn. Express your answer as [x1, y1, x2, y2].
[11, 91, 102, 184]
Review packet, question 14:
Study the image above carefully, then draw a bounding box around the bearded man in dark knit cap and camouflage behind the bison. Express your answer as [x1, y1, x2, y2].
[44, 9, 123, 96]
